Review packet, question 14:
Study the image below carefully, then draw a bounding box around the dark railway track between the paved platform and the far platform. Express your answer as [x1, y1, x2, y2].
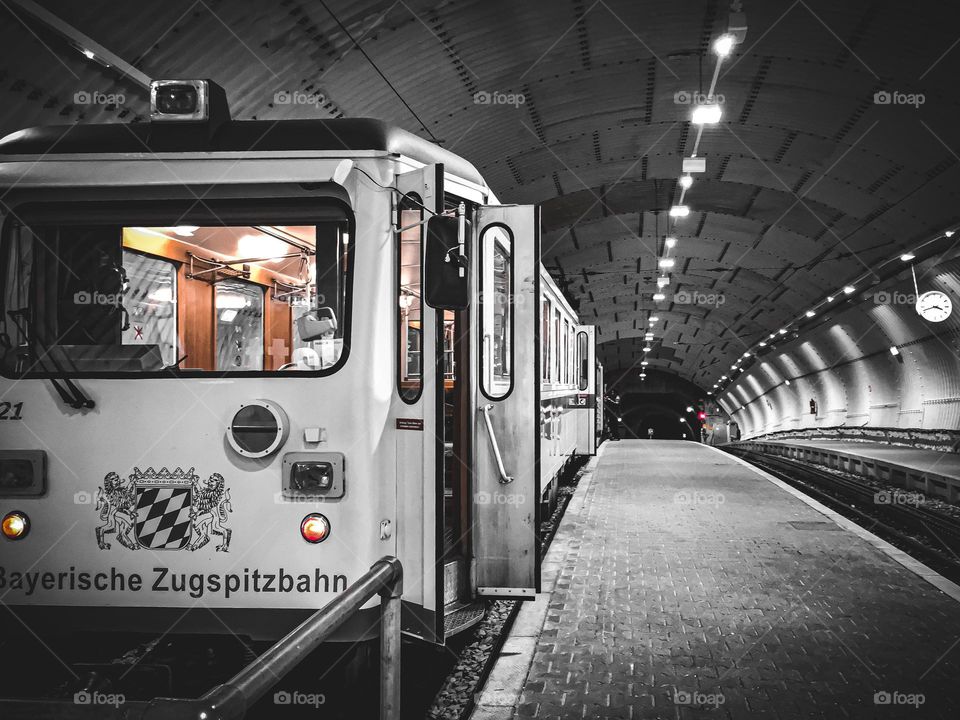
[724, 447, 960, 582]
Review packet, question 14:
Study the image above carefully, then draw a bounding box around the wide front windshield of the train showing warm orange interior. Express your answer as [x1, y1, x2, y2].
[0, 200, 351, 377]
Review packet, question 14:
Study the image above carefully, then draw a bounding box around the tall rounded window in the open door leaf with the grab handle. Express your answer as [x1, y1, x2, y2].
[480, 226, 513, 398]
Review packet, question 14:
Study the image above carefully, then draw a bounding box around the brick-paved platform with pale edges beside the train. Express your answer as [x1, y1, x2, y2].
[473, 440, 960, 720]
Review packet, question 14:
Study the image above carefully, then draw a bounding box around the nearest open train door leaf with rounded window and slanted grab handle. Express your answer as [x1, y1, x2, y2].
[469, 205, 540, 598]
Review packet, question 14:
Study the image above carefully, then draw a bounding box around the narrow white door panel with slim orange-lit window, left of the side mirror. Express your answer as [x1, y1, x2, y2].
[394, 164, 444, 642]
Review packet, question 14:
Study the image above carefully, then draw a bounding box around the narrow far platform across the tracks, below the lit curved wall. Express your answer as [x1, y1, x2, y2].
[735, 439, 960, 502]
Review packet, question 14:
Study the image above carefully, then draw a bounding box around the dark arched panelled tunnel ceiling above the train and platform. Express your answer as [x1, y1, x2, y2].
[0, 0, 960, 394]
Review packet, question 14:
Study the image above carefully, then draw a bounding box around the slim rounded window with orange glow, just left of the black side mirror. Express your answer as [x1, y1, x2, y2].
[397, 195, 423, 402]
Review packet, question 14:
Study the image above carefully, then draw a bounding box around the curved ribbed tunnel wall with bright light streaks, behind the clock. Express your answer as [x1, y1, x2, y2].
[718, 253, 960, 438]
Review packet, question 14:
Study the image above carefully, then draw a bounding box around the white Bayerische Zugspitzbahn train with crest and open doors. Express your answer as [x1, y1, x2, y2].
[0, 80, 603, 696]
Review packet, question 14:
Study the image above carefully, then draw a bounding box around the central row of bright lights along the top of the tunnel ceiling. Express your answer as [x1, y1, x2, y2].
[640, 32, 742, 386]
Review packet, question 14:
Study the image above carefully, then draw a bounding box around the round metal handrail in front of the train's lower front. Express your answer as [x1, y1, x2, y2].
[0, 556, 403, 720]
